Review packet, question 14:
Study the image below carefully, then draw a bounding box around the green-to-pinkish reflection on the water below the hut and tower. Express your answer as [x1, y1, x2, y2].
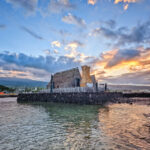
[29, 103, 110, 150]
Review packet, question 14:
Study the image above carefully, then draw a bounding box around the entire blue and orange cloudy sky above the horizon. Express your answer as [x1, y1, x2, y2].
[0, 0, 150, 85]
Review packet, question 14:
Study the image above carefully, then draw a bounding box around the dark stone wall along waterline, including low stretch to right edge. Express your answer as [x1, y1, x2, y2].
[17, 92, 150, 105]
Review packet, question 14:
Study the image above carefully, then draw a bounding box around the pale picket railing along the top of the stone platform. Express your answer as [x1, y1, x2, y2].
[40, 87, 104, 93]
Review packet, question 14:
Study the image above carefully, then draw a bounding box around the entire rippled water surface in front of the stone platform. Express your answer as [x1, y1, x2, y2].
[0, 98, 150, 150]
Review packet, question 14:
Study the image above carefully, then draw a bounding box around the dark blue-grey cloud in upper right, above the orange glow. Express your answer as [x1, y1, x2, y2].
[92, 21, 150, 46]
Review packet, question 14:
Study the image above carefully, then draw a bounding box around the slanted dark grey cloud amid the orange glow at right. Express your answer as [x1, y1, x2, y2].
[106, 49, 140, 68]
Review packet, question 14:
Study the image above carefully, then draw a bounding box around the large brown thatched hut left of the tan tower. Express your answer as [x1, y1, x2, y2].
[47, 68, 81, 89]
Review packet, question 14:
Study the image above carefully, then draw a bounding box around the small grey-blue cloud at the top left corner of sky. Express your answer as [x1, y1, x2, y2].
[6, 0, 38, 13]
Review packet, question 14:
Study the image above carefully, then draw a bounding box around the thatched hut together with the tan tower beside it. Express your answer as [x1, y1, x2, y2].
[47, 66, 97, 89]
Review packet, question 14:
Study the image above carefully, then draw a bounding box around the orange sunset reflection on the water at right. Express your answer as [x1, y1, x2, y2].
[99, 104, 150, 150]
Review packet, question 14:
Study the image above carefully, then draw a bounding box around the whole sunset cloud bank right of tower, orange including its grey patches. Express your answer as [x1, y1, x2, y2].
[91, 47, 150, 84]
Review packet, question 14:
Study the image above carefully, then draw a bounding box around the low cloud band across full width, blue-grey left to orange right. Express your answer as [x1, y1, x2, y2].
[0, 46, 150, 84]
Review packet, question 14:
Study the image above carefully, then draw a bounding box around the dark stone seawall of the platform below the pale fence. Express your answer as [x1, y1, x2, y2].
[17, 92, 122, 105]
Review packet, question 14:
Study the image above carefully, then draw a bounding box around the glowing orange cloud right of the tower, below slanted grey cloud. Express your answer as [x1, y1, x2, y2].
[92, 48, 150, 81]
